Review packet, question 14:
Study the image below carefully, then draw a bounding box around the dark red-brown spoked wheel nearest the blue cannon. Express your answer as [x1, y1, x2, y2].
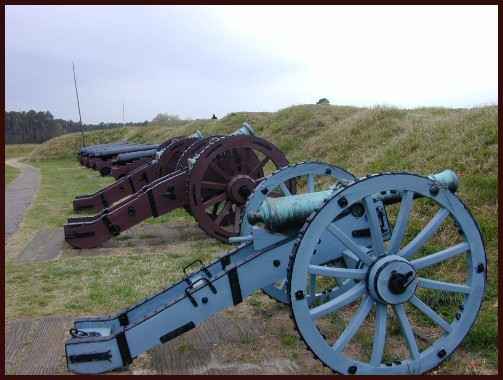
[188, 135, 288, 242]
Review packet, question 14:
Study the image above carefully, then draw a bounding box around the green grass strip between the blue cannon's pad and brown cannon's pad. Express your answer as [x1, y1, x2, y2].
[5, 248, 215, 319]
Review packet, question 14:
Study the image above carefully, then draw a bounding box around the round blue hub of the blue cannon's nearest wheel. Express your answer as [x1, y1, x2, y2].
[368, 255, 418, 305]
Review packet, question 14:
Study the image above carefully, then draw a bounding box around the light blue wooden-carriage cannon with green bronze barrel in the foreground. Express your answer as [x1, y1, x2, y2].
[65, 162, 487, 375]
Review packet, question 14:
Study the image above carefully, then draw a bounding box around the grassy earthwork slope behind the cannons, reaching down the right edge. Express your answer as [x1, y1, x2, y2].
[15, 105, 498, 372]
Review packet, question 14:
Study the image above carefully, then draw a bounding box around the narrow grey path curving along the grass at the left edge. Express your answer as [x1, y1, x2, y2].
[5, 158, 40, 239]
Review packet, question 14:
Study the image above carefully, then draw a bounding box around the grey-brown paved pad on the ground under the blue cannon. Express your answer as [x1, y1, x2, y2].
[5, 314, 300, 375]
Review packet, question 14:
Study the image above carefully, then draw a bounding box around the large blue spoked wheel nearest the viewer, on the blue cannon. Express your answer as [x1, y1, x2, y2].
[288, 173, 487, 375]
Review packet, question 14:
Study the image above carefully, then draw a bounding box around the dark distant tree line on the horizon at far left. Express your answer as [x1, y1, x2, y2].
[5, 110, 148, 144]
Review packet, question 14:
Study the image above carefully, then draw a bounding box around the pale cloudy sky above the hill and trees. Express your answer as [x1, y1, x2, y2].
[5, 5, 498, 123]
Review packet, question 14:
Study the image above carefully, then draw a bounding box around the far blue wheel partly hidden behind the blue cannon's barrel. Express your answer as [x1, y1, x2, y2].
[240, 162, 355, 304]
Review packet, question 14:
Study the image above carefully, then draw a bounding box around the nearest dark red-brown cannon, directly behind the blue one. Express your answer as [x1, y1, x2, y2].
[64, 125, 288, 248]
